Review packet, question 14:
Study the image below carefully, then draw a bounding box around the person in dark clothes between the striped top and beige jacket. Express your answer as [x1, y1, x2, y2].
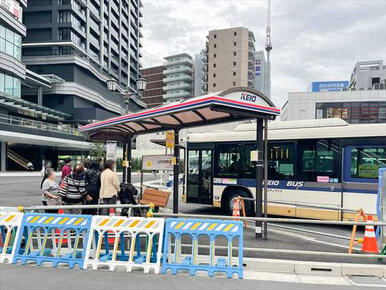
[83, 161, 101, 215]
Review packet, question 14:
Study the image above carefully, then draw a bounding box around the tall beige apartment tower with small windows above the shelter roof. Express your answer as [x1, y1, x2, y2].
[205, 27, 256, 92]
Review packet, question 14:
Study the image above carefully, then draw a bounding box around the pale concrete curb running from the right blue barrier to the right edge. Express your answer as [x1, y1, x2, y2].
[244, 258, 386, 278]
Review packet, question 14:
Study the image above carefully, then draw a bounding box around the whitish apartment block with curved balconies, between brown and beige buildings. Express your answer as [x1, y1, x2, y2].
[163, 53, 194, 102]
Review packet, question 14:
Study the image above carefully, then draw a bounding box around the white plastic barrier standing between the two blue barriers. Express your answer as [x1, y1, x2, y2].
[83, 216, 165, 274]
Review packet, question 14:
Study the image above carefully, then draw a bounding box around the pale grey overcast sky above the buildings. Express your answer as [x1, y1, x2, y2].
[142, 0, 386, 106]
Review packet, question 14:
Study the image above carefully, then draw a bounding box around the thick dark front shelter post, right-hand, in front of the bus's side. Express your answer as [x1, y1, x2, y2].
[255, 118, 263, 238]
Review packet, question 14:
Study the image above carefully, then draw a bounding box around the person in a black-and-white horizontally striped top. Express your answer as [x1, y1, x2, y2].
[59, 164, 92, 214]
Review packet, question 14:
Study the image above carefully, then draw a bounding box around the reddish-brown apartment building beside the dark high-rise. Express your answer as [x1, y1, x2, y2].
[141, 65, 165, 108]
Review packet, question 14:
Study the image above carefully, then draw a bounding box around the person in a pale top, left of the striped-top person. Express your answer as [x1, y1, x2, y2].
[41, 169, 62, 213]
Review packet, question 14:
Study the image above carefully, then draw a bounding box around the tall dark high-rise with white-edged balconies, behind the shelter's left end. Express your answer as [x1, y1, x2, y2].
[23, 0, 143, 123]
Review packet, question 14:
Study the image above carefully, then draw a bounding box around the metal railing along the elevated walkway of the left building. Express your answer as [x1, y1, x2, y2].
[0, 114, 82, 136]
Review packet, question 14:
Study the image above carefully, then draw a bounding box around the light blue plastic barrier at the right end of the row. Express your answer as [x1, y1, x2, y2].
[161, 218, 244, 279]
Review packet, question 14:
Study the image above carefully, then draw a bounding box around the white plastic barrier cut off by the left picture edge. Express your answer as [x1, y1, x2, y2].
[0, 212, 23, 263]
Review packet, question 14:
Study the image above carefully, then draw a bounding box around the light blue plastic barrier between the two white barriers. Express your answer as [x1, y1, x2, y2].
[13, 213, 92, 268]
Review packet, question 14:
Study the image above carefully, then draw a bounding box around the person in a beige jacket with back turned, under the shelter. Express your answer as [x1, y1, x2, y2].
[99, 160, 120, 215]
